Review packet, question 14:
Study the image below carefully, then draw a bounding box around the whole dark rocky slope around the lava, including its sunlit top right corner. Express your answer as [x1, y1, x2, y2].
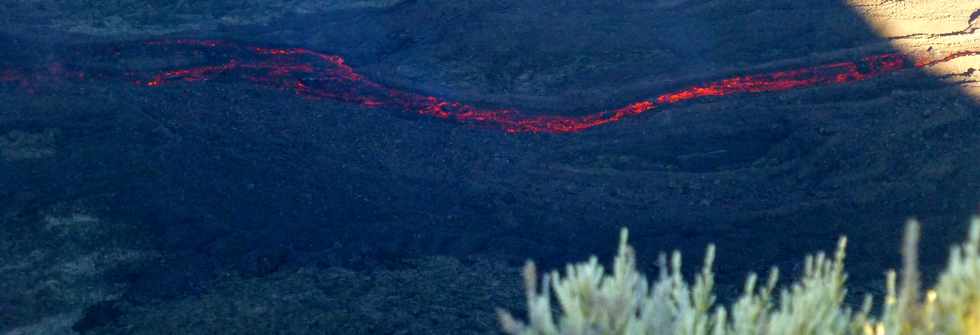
[0, 0, 980, 334]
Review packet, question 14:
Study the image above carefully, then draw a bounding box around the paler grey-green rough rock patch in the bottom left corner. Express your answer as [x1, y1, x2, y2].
[0, 202, 154, 334]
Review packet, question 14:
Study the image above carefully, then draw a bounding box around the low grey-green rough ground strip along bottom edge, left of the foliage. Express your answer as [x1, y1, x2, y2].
[99, 257, 522, 334]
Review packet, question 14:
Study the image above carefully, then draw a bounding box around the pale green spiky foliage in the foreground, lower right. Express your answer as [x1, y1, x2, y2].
[499, 218, 980, 335]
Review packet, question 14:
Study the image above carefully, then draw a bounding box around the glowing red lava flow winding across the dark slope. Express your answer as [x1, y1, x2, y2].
[0, 39, 980, 133]
